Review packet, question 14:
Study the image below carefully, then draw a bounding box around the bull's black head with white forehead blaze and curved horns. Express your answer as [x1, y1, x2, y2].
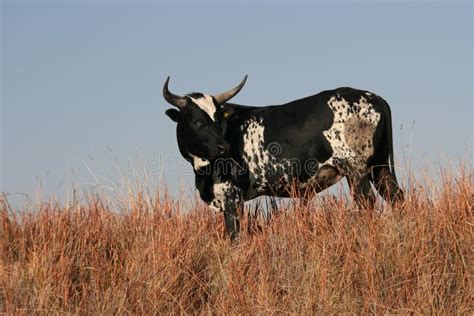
[163, 76, 247, 170]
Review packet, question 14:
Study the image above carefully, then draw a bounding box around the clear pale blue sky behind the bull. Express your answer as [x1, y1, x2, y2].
[0, 1, 473, 203]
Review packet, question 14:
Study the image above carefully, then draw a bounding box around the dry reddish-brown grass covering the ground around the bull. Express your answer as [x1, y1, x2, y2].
[0, 171, 474, 314]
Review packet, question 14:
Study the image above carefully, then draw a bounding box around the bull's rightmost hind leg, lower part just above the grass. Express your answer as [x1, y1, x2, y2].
[373, 166, 404, 204]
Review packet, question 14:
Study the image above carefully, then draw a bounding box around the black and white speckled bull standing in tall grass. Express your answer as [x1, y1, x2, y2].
[163, 77, 403, 239]
